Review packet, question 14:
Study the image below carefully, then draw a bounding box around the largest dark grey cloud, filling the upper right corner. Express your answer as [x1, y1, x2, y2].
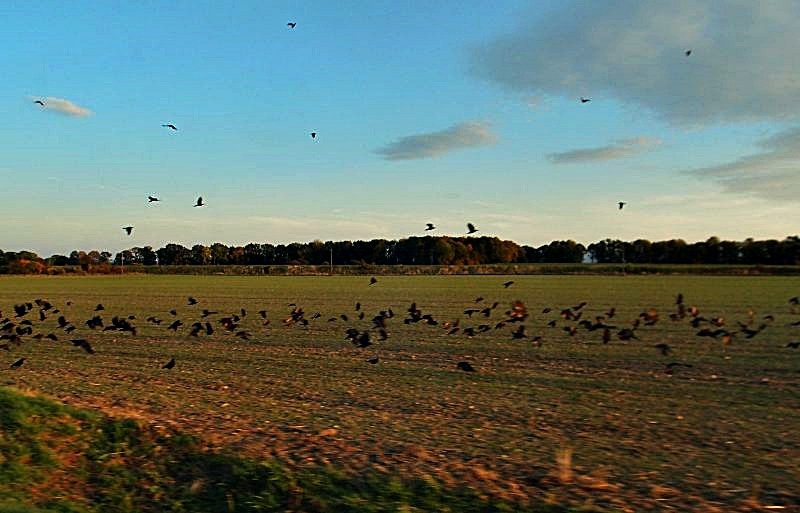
[470, 0, 800, 126]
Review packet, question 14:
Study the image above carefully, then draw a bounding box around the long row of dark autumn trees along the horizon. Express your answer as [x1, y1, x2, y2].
[0, 236, 800, 273]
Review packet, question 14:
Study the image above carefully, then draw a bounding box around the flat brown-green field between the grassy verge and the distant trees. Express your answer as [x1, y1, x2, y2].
[0, 276, 800, 511]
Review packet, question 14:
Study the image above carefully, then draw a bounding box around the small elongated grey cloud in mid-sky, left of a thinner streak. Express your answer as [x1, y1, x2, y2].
[375, 121, 497, 160]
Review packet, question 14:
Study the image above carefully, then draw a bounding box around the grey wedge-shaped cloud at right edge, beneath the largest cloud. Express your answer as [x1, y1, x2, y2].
[686, 127, 800, 201]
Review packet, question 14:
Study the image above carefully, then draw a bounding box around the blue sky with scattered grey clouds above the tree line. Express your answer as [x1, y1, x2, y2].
[0, 0, 800, 255]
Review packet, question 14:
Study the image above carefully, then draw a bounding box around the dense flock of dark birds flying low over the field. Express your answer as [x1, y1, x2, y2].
[0, 277, 800, 375]
